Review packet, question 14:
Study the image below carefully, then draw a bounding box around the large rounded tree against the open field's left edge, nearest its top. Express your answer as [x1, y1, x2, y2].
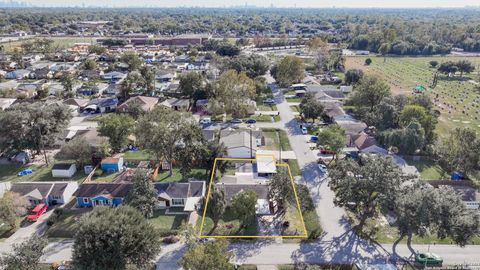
[350, 76, 390, 112]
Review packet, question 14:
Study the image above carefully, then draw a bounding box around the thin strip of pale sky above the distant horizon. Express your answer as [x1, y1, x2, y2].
[16, 0, 480, 8]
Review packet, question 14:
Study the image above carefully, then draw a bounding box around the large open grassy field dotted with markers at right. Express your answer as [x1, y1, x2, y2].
[346, 56, 480, 136]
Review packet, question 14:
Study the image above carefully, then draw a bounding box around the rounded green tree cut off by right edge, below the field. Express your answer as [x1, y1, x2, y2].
[436, 128, 480, 174]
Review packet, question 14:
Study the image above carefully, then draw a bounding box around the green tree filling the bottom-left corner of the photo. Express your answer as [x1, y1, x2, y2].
[0, 233, 48, 270]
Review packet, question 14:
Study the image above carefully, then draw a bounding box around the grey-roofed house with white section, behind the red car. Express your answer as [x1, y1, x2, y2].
[10, 182, 78, 205]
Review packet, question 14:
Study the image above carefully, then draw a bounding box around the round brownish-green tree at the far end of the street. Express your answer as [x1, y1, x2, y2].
[270, 56, 305, 87]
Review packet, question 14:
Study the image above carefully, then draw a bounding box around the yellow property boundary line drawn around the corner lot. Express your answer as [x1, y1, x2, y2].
[198, 154, 308, 239]
